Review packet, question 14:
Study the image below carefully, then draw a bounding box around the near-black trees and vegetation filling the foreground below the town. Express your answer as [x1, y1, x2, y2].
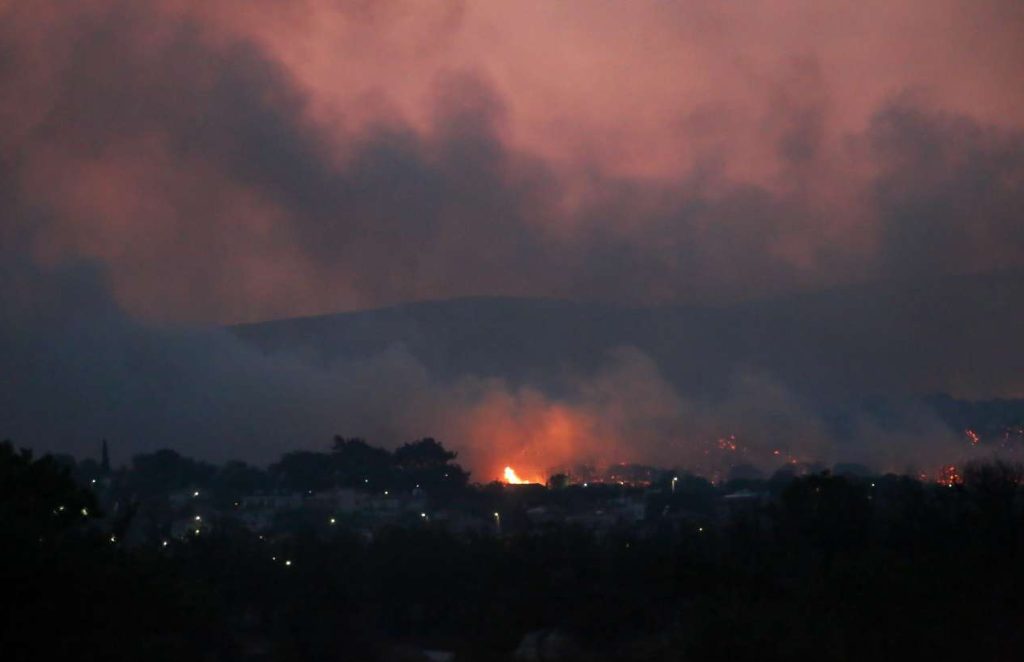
[0, 444, 1024, 661]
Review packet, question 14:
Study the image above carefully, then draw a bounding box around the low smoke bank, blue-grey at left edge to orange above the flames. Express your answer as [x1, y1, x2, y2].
[0, 257, 983, 481]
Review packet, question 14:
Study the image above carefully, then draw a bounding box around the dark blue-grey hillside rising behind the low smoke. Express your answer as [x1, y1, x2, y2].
[232, 272, 1024, 398]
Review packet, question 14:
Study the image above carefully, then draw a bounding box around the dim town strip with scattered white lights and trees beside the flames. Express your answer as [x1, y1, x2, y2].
[59, 437, 963, 547]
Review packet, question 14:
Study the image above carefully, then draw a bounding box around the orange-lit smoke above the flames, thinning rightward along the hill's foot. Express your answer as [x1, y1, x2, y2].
[435, 347, 981, 480]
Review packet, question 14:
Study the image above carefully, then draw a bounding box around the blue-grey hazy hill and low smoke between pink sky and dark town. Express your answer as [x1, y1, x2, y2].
[0, 259, 1022, 480]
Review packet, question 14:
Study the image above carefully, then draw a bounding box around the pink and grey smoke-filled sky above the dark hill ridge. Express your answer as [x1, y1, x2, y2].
[0, 0, 1024, 477]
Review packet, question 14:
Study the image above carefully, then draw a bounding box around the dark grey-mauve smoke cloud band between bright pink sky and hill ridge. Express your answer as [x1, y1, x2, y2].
[2, 2, 1024, 321]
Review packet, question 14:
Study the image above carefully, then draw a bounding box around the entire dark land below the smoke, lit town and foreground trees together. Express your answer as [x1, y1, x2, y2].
[8, 437, 1024, 662]
